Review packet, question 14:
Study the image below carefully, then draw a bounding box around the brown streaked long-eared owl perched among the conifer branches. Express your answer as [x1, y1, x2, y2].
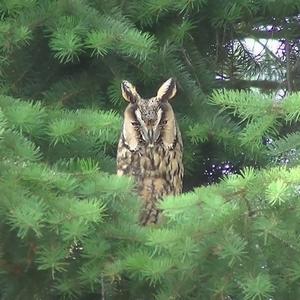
[117, 78, 183, 225]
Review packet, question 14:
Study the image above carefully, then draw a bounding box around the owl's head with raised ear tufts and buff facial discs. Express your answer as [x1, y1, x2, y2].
[121, 78, 177, 151]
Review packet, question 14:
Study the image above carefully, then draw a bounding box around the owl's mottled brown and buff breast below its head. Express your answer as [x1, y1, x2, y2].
[117, 143, 183, 201]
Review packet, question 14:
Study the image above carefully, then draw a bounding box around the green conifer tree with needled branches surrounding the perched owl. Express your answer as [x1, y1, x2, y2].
[0, 0, 300, 300]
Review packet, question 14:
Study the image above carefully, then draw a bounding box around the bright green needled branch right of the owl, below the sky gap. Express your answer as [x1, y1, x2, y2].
[211, 91, 300, 156]
